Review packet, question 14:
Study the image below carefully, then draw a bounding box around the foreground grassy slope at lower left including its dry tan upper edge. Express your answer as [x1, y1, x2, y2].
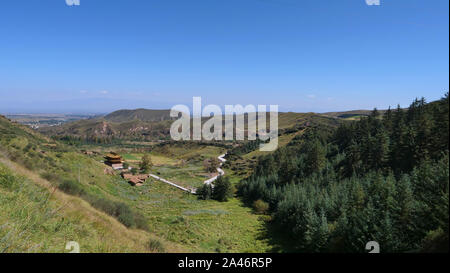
[0, 158, 185, 253]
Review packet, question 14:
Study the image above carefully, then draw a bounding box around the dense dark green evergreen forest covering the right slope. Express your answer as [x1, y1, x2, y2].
[239, 93, 449, 252]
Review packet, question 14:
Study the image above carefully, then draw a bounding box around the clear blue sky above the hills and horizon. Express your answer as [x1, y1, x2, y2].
[0, 0, 449, 113]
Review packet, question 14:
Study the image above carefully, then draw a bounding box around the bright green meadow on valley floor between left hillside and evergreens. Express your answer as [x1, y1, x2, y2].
[130, 178, 271, 252]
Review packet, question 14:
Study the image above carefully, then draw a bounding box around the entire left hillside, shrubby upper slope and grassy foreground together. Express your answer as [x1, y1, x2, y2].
[0, 113, 185, 252]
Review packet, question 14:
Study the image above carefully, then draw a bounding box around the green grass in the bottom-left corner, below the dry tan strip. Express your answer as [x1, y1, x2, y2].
[0, 164, 151, 253]
